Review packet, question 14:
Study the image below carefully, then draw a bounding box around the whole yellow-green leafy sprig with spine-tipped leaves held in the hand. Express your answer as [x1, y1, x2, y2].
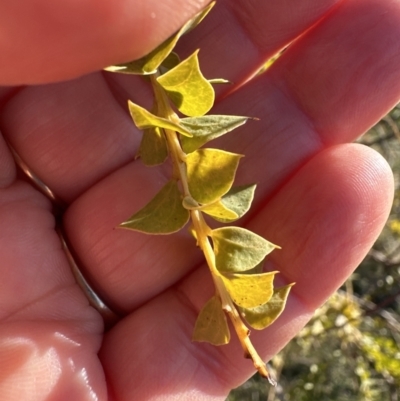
[106, 3, 292, 383]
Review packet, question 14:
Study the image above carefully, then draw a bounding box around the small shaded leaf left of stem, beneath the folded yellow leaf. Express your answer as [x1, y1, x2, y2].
[138, 127, 168, 166]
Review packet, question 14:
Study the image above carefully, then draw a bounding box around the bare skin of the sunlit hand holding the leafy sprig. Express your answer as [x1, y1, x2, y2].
[0, 0, 400, 401]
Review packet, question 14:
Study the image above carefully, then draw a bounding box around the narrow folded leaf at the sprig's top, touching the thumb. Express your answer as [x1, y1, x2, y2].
[105, 2, 215, 75]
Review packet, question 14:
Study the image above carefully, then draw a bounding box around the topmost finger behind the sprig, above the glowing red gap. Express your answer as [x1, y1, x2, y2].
[178, 0, 343, 92]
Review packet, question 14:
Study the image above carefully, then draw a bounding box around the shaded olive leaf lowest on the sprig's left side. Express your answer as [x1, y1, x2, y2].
[192, 296, 230, 345]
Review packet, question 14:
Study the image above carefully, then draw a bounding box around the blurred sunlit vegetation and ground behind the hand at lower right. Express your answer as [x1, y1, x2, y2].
[227, 105, 400, 401]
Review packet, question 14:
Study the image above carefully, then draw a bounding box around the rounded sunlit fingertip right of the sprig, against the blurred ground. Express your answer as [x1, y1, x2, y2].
[266, 144, 393, 310]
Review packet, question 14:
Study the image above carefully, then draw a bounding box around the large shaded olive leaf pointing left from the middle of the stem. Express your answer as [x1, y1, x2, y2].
[120, 180, 189, 234]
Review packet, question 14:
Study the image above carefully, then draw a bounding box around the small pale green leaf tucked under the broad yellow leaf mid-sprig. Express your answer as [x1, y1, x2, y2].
[216, 184, 256, 223]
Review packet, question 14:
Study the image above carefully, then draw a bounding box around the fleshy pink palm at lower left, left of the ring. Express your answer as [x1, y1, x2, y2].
[0, 181, 106, 401]
